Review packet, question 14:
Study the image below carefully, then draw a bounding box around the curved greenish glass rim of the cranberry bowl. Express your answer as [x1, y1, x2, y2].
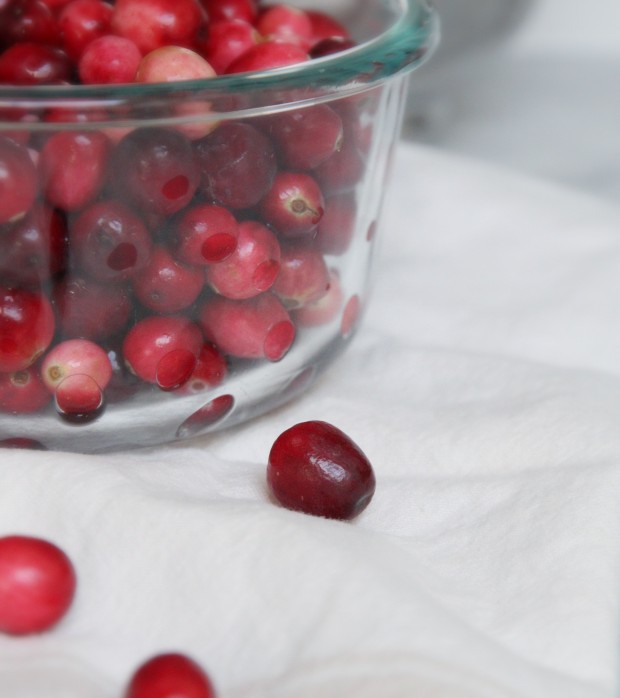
[0, 0, 439, 123]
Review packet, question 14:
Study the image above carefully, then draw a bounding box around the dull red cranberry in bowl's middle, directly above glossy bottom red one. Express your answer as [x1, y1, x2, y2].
[133, 245, 205, 314]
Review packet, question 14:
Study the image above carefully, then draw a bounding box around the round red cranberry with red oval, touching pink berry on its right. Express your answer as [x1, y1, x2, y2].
[175, 204, 239, 266]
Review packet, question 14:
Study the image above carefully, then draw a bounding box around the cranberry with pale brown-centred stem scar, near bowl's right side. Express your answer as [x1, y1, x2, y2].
[260, 172, 325, 238]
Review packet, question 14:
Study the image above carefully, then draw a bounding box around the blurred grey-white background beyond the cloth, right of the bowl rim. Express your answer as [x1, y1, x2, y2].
[404, 0, 620, 203]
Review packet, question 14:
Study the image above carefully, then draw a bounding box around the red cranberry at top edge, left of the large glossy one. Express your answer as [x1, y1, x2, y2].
[58, 0, 113, 61]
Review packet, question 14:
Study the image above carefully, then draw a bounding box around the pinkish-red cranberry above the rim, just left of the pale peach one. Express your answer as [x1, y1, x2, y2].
[78, 34, 142, 85]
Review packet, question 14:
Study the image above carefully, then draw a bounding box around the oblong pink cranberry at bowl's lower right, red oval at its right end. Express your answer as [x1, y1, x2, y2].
[200, 293, 295, 361]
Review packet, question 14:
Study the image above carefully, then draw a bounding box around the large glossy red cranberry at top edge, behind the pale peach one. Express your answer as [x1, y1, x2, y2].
[112, 0, 203, 55]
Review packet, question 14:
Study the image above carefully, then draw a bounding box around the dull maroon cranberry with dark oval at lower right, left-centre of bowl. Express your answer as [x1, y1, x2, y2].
[69, 200, 152, 281]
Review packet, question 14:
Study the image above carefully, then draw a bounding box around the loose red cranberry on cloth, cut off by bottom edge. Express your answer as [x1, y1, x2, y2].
[124, 653, 215, 698]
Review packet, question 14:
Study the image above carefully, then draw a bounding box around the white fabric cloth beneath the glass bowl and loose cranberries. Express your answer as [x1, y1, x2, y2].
[0, 144, 620, 698]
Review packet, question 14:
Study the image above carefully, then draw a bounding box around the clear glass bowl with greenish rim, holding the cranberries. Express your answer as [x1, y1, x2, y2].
[0, 0, 437, 452]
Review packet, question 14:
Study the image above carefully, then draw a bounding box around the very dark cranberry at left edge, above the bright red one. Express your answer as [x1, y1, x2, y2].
[0, 204, 67, 286]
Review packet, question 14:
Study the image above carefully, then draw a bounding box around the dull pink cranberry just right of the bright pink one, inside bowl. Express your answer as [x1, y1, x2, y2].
[272, 243, 329, 308]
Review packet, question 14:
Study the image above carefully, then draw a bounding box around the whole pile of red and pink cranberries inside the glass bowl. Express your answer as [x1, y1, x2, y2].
[0, 0, 375, 437]
